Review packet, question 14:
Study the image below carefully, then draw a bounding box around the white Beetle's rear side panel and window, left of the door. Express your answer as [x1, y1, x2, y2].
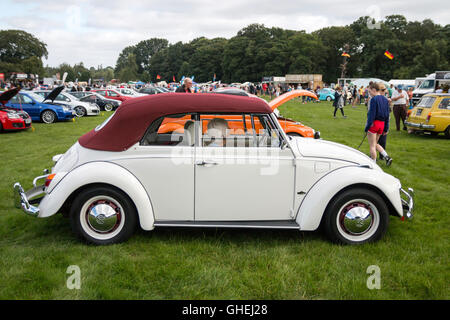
[118, 114, 195, 221]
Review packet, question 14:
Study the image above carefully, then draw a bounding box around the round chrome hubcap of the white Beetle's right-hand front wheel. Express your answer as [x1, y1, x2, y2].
[339, 201, 374, 235]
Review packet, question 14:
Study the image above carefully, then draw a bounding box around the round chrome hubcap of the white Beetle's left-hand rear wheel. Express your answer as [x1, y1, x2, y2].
[86, 200, 122, 233]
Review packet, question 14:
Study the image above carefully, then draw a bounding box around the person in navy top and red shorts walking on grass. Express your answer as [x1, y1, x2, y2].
[364, 82, 392, 166]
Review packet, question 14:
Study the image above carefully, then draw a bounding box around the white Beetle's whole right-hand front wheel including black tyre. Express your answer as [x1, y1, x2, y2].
[324, 188, 389, 244]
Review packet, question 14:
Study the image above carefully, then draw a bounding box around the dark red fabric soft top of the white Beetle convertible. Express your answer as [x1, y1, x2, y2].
[78, 93, 272, 151]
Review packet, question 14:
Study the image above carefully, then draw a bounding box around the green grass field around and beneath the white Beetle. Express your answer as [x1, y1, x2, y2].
[0, 100, 450, 299]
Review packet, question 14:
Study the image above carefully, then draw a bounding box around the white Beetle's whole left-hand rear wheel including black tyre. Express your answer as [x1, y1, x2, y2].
[70, 186, 138, 245]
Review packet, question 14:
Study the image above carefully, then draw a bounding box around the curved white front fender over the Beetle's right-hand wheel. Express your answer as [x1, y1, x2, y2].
[296, 166, 403, 230]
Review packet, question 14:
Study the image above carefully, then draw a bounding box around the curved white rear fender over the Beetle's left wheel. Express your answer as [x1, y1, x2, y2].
[39, 162, 155, 230]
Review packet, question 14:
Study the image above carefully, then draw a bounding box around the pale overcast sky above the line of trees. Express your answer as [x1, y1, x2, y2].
[0, 0, 450, 67]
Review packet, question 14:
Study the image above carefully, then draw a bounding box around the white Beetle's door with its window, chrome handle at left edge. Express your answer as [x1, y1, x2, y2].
[195, 114, 295, 221]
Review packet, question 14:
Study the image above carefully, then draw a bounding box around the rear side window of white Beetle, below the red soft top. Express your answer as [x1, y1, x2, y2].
[141, 113, 195, 147]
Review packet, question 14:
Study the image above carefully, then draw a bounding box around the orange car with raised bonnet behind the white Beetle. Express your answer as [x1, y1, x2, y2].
[213, 87, 320, 139]
